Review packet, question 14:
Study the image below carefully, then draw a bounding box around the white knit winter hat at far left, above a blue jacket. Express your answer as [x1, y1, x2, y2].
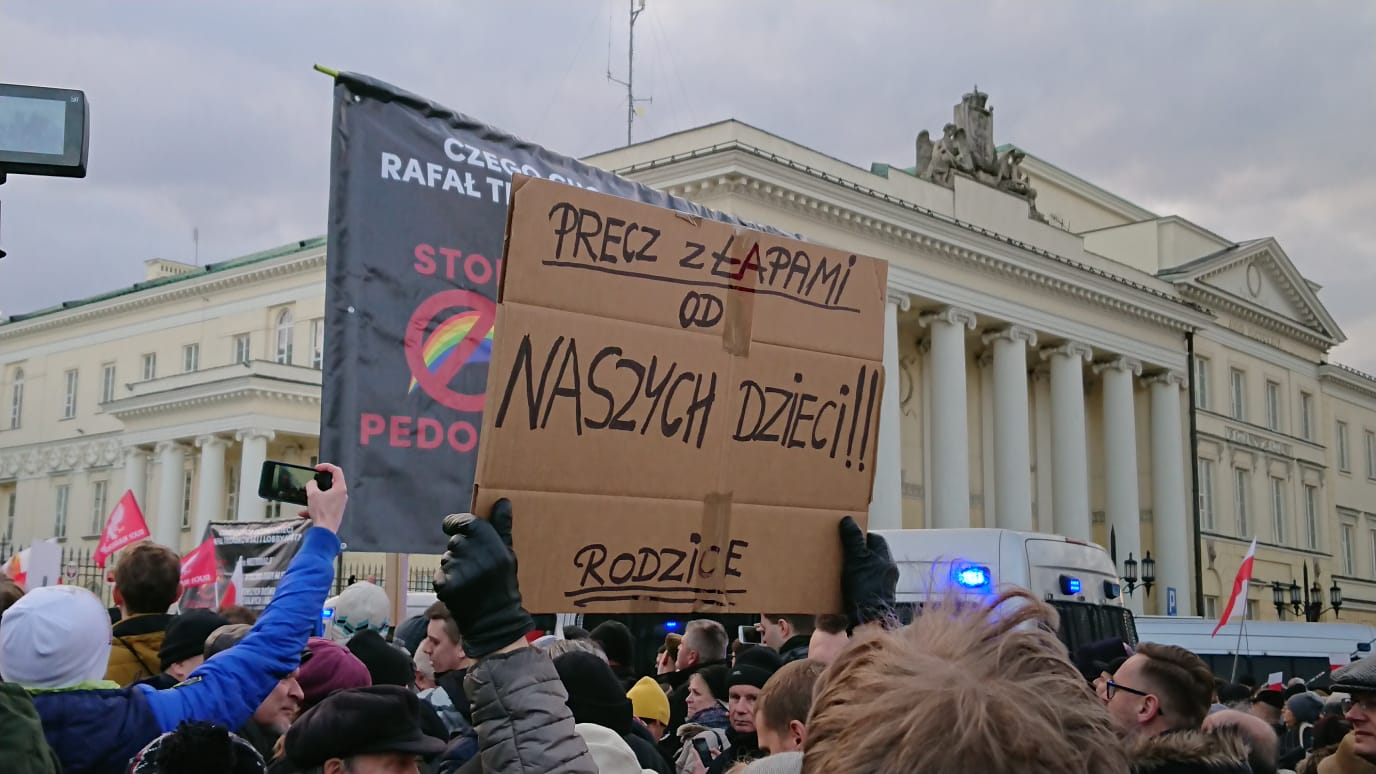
[0, 585, 110, 689]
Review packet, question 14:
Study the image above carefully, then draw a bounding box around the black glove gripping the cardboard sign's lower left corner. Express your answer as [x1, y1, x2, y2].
[435, 500, 535, 658]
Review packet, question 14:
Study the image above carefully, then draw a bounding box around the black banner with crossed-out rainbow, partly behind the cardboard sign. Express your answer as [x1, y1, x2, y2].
[321, 73, 781, 554]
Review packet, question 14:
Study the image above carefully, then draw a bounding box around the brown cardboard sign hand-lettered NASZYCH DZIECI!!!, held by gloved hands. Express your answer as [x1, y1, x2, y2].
[475, 176, 888, 613]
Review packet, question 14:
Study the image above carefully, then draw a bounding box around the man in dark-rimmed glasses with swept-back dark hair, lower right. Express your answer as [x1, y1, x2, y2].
[1095, 642, 1249, 774]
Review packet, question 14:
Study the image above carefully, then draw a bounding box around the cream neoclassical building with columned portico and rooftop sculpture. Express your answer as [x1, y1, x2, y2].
[0, 94, 1376, 620]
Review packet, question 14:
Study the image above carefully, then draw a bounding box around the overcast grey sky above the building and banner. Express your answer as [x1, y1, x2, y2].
[0, 0, 1376, 370]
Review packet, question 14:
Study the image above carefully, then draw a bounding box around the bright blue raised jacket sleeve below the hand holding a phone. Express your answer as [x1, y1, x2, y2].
[136, 527, 340, 733]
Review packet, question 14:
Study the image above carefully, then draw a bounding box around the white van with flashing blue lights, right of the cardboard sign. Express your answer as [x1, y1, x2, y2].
[875, 529, 1137, 653]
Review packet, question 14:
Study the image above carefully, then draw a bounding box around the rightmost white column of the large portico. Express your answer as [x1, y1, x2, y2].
[1148, 370, 1194, 616]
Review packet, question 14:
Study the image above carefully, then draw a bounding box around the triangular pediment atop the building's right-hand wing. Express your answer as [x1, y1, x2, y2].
[1160, 237, 1347, 350]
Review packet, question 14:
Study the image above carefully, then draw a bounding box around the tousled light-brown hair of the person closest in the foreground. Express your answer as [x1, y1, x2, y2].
[802, 589, 1128, 774]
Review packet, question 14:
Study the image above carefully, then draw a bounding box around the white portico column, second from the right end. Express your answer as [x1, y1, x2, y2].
[1094, 358, 1145, 616]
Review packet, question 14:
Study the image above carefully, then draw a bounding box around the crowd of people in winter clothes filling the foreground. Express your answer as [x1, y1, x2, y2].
[0, 466, 1376, 774]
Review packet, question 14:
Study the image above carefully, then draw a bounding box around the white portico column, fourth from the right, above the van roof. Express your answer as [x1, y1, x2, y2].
[984, 325, 1036, 532]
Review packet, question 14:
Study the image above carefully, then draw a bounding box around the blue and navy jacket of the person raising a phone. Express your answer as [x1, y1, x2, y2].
[30, 527, 340, 774]
